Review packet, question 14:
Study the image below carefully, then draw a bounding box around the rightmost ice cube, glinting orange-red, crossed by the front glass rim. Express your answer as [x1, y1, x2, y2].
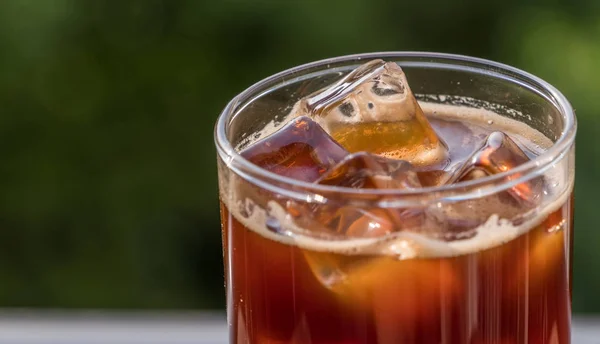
[448, 131, 542, 205]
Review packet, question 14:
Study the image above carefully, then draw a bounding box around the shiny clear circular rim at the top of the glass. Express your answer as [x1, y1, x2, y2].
[214, 51, 577, 201]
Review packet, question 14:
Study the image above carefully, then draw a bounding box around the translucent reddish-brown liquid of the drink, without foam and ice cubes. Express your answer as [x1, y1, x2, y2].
[221, 113, 573, 344]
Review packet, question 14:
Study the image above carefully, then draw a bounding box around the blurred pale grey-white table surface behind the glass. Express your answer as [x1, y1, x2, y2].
[0, 310, 600, 344]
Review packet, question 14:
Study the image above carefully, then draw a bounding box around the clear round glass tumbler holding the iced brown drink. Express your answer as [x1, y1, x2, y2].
[215, 52, 576, 344]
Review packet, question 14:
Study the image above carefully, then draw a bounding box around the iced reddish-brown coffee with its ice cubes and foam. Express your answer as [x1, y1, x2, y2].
[220, 59, 574, 344]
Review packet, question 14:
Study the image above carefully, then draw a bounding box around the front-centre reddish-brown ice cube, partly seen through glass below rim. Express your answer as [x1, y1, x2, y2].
[288, 152, 422, 238]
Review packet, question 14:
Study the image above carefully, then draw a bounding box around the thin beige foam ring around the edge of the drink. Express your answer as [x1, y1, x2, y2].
[221, 102, 574, 259]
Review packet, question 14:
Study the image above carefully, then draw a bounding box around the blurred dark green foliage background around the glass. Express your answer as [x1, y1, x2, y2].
[0, 0, 600, 312]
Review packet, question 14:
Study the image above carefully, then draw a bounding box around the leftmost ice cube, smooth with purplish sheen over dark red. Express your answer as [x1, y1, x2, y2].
[241, 116, 349, 182]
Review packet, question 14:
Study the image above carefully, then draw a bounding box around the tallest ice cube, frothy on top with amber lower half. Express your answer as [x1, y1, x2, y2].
[293, 60, 448, 166]
